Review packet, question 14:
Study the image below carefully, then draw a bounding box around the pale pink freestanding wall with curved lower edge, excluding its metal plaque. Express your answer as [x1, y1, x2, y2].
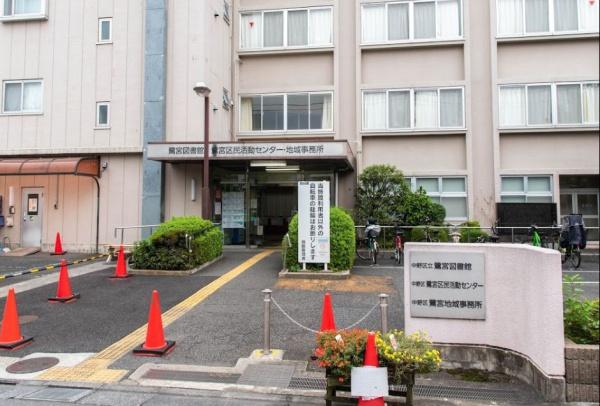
[404, 243, 565, 376]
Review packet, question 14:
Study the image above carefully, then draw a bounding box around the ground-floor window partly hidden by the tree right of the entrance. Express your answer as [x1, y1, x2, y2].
[410, 177, 468, 221]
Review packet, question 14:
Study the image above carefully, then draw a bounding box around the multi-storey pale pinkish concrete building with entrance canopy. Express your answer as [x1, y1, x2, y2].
[0, 0, 600, 251]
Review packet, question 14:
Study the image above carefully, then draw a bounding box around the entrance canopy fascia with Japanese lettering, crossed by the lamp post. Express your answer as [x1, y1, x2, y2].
[148, 141, 355, 170]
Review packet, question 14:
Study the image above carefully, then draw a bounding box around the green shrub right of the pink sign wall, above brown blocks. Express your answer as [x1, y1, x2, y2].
[563, 274, 600, 344]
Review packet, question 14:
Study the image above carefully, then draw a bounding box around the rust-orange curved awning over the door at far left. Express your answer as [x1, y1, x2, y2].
[0, 157, 100, 177]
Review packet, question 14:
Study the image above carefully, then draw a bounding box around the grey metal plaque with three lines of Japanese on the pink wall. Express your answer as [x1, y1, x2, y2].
[408, 248, 485, 320]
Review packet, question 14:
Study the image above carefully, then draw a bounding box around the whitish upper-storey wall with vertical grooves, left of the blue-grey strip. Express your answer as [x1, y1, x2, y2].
[0, 0, 144, 155]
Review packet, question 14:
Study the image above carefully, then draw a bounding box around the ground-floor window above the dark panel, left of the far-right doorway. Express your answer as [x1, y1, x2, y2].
[500, 175, 553, 203]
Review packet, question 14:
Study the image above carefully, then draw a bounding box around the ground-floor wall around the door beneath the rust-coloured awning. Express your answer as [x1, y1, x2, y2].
[0, 155, 141, 252]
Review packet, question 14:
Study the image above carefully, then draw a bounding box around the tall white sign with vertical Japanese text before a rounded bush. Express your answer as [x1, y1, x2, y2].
[298, 181, 330, 264]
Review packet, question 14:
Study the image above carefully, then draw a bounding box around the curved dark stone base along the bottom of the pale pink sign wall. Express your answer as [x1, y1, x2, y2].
[435, 343, 568, 402]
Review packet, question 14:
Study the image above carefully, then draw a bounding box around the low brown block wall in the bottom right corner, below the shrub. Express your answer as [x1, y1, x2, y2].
[565, 338, 600, 402]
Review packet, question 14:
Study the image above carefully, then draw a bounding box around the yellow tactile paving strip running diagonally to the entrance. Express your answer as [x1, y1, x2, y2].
[37, 250, 273, 383]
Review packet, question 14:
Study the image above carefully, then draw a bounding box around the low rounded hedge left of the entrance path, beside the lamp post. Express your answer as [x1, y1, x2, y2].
[131, 216, 223, 270]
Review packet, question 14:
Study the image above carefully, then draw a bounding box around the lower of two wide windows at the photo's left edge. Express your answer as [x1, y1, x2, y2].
[2, 80, 43, 114]
